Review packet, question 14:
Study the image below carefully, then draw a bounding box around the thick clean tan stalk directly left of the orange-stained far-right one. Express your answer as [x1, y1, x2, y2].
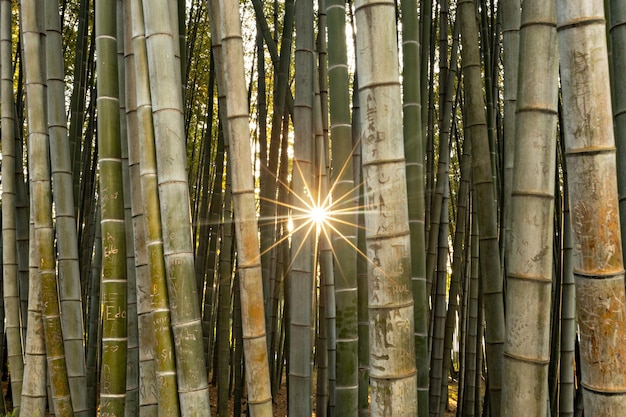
[502, 0, 558, 416]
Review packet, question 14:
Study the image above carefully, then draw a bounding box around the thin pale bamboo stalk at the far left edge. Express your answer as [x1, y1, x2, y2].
[0, 0, 24, 415]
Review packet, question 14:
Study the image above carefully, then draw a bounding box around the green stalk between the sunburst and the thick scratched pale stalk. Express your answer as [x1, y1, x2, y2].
[326, 0, 359, 416]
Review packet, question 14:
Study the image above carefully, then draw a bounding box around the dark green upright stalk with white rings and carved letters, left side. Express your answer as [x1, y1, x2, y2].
[96, 2, 128, 416]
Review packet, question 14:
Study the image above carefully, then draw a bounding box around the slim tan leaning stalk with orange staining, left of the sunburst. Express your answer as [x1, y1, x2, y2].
[219, 0, 272, 417]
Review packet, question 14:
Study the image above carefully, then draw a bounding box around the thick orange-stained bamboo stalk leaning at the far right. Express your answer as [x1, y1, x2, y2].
[557, 0, 626, 417]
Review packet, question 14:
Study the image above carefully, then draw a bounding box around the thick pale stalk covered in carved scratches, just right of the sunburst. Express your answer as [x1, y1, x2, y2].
[355, 0, 417, 416]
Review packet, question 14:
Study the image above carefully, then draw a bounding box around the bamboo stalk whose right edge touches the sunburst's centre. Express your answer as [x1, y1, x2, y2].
[288, 0, 317, 415]
